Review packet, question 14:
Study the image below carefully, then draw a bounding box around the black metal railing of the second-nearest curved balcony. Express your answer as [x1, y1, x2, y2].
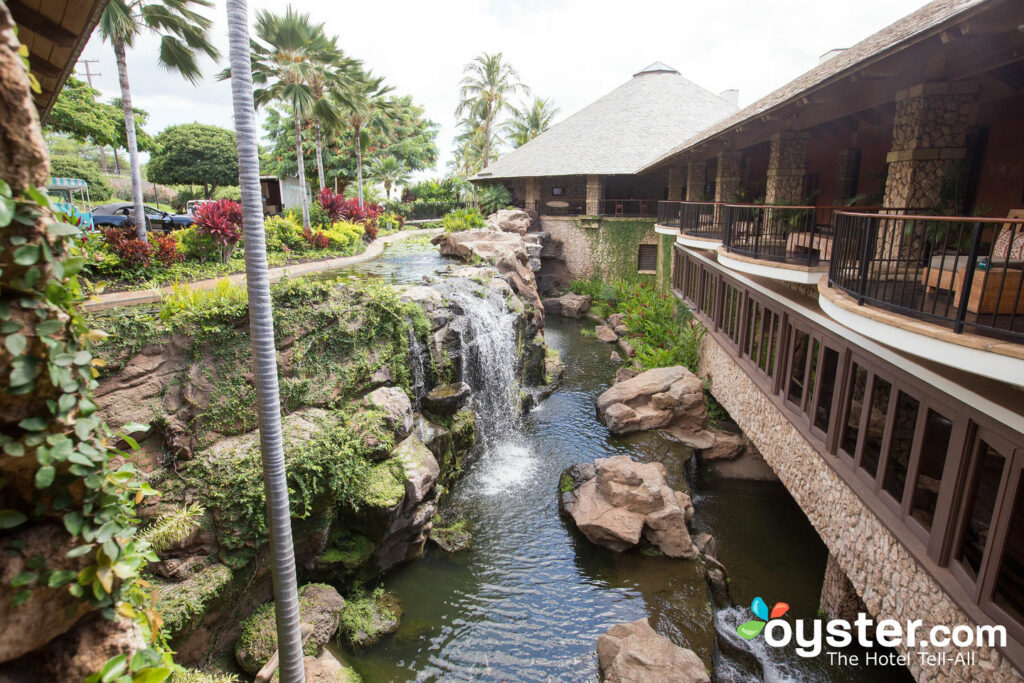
[716, 204, 819, 266]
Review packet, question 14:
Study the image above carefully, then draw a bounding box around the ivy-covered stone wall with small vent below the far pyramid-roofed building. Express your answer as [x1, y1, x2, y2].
[541, 216, 662, 282]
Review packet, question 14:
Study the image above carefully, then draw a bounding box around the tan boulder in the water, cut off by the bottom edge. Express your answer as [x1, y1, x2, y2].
[597, 618, 711, 683]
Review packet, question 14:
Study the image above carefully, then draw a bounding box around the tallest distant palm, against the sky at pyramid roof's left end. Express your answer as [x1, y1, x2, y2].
[456, 52, 529, 168]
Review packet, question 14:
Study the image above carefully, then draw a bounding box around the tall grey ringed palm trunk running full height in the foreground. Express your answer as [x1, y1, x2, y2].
[227, 0, 305, 683]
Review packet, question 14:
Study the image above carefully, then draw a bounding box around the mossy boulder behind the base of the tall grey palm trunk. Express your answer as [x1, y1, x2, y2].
[234, 584, 345, 676]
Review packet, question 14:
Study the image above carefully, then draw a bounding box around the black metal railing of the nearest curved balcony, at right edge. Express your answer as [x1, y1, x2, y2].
[828, 211, 1024, 343]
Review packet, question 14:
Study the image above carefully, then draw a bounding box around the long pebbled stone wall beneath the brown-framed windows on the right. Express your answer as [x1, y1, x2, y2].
[699, 335, 1019, 681]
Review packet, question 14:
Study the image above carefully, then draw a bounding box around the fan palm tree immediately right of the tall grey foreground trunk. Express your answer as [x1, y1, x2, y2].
[220, 5, 341, 227]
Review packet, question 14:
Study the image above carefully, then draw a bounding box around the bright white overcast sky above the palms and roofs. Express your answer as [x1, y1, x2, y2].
[77, 0, 925, 177]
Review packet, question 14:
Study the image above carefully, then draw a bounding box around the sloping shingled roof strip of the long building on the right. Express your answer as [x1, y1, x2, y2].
[641, 0, 990, 170]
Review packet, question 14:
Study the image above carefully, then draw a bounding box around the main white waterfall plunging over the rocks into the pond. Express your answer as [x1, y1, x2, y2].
[444, 280, 536, 495]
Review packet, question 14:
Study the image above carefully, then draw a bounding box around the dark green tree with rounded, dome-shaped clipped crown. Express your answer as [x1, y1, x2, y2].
[145, 123, 239, 199]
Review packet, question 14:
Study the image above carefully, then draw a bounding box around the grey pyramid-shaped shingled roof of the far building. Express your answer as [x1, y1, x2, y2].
[474, 61, 736, 180]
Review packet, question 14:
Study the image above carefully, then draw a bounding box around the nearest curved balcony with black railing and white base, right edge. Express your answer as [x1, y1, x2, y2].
[819, 211, 1024, 386]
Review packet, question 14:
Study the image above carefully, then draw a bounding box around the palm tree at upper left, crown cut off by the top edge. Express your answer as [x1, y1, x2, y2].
[99, 0, 220, 241]
